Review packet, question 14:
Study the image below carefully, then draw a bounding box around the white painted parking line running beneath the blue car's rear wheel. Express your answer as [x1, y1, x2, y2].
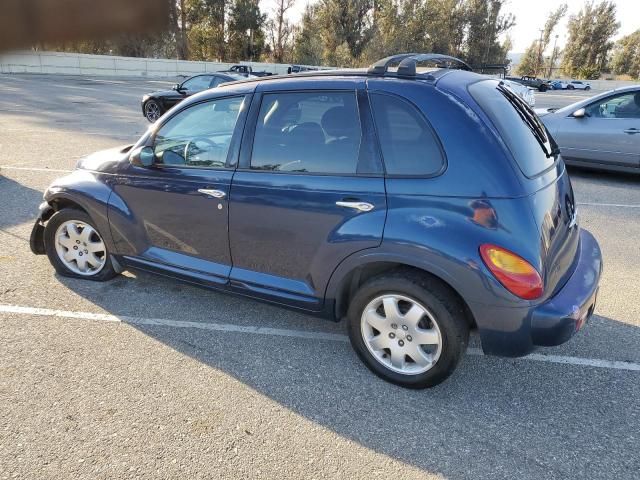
[0, 304, 640, 372]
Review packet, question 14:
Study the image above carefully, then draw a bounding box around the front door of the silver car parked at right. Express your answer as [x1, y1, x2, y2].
[554, 92, 640, 167]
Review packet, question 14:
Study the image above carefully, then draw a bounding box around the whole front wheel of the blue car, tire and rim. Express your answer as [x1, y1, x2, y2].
[44, 208, 117, 282]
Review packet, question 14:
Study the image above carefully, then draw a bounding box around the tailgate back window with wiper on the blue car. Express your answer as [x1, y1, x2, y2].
[469, 80, 557, 177]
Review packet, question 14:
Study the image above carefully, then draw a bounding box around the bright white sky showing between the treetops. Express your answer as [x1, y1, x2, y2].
[260, 0, 640, 53]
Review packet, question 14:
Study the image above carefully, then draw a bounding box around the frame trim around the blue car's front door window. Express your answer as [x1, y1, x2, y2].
[144, 93, 253, 171]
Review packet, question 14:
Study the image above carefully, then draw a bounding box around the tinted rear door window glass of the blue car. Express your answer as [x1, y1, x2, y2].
[251, 92, 362, 174]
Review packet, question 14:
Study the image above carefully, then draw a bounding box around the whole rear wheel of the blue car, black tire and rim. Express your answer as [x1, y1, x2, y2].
[347, 270, 469, 389]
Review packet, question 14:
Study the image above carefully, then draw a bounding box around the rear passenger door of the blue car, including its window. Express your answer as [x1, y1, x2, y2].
[229, 85, 386, 311]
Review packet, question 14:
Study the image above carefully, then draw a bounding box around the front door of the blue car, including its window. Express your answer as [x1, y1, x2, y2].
[109, 96, 249, 283]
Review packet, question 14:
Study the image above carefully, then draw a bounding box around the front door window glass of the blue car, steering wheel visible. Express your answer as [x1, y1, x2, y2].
[153, 97, 244, 168]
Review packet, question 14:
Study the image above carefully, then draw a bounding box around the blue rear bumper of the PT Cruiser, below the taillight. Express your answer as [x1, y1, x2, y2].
[470, 230, 602, 357]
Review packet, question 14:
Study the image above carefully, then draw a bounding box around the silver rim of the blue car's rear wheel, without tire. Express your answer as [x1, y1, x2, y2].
[360, 294, 442, 375]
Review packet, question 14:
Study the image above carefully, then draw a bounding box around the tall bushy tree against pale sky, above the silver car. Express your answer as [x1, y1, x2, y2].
[562, 0, 620, 78]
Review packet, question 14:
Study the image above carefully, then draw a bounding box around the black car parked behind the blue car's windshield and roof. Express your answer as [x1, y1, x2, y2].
[142, 73, 244, 123]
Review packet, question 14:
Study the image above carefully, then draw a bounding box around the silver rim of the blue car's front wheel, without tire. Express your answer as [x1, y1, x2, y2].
[56, 220, 107, 276]
